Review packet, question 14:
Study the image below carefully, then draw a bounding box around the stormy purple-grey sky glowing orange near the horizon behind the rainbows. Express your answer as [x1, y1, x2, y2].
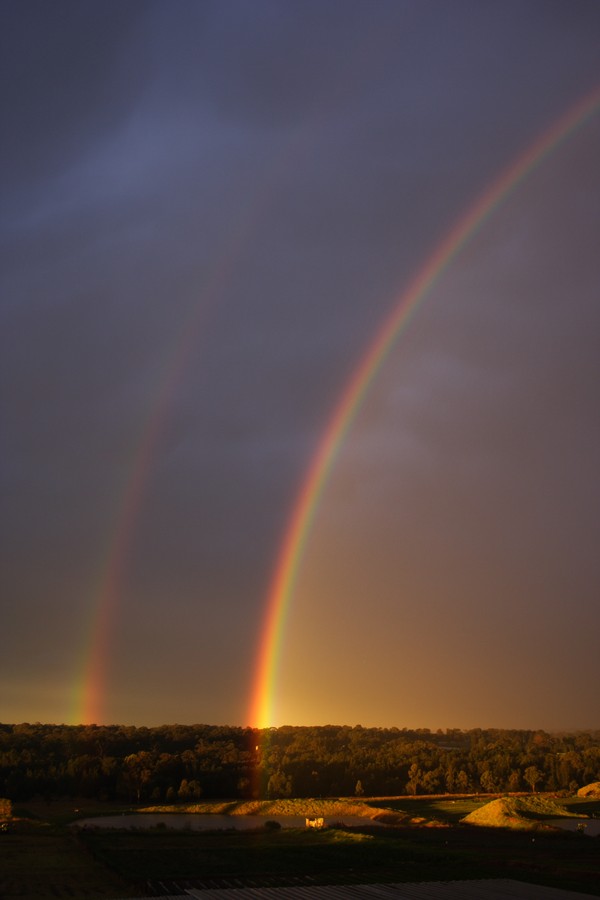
[0, 0, 600, 728]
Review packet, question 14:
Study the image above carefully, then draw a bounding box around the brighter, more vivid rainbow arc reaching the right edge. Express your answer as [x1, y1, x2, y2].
[249, 86, 600, 728]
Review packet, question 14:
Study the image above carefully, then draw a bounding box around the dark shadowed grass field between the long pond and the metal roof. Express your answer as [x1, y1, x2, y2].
[81, 826, 598, 893]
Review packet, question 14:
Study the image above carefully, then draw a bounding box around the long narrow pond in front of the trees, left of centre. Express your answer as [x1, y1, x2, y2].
[72, 813, 372, 831]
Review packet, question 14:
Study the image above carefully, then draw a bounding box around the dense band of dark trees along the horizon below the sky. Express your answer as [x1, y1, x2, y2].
[0, 723, 600, 803]
